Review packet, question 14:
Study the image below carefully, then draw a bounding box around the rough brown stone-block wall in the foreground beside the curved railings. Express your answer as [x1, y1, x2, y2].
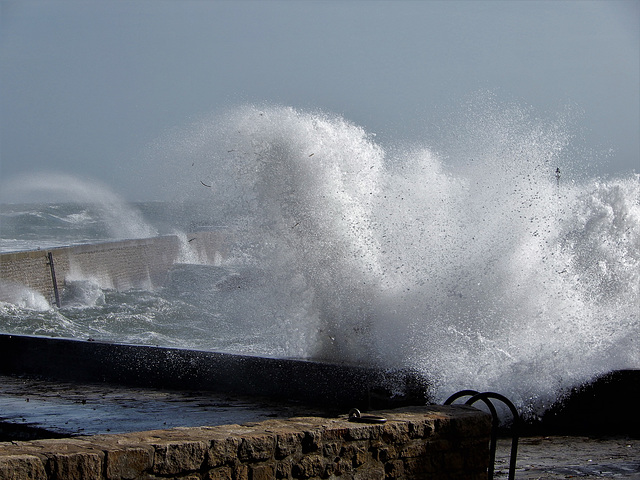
[0, 406, 491, 480]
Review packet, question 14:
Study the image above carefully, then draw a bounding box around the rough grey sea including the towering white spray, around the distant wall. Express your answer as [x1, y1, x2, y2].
[0, 102, 640, 414]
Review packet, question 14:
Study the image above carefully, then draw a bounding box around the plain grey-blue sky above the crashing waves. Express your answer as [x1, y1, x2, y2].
[0, 0, 640, 196]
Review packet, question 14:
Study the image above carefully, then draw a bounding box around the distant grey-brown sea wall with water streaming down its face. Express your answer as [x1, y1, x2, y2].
[0, 232, 225, 304]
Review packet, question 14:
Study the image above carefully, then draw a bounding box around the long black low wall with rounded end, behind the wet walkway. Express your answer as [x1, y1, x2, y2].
[0, 334, 428, 409]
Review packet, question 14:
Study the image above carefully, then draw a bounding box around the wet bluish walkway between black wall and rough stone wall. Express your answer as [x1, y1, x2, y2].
[0, 376, 323, 440]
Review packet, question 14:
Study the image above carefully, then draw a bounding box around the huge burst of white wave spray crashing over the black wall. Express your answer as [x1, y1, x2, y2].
[149, 101, 640, 405]
